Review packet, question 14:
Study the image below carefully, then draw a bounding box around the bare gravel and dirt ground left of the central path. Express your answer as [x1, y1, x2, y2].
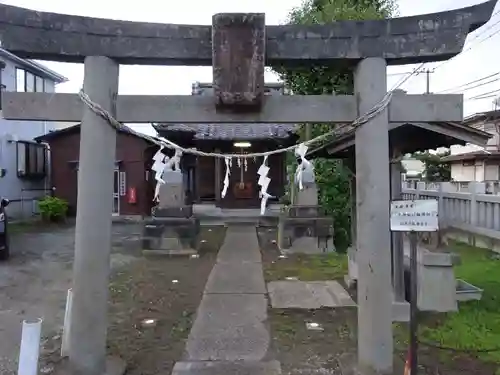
[0, 223, 224, 375]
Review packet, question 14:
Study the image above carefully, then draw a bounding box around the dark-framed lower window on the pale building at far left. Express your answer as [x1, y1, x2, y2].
[17, 141, 47, 178]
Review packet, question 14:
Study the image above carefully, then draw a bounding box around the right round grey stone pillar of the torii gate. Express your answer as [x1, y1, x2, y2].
[354, 57, 393, 373]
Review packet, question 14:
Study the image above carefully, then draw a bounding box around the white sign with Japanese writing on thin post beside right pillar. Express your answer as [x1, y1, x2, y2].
[391, 200, 439, 375]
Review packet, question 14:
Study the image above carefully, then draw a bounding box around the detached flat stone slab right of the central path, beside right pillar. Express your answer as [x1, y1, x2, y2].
[267, 281, 356, 309]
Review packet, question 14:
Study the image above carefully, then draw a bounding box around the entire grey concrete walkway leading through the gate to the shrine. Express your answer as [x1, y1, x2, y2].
[173, 225, 281, 375]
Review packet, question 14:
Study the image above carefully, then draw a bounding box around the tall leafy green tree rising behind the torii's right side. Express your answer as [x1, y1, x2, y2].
[273, 0, 396, 251]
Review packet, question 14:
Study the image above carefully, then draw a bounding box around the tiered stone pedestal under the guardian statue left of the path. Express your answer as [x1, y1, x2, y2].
[143, 171, 200, 255]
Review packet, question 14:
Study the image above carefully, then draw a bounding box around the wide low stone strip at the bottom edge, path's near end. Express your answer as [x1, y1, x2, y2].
[172, 361, 281, 375]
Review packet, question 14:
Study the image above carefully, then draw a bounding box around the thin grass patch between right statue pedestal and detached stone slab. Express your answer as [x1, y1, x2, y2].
[265, 253, 347, 281]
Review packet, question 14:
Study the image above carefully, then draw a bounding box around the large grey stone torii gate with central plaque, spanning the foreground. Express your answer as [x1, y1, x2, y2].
[0, 0, 496, 375]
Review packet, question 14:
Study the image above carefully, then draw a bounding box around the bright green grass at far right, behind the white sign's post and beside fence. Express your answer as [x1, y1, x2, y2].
[421, 243, 500, 363]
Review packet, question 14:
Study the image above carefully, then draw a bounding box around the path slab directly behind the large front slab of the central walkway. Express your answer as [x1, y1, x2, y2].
[205, 263, 267, 294]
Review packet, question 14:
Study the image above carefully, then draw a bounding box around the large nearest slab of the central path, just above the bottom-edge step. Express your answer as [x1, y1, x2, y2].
[186, 294, 270, 361]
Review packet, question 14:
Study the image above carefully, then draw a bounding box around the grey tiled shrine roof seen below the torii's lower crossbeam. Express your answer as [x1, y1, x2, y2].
[153, 124, 298, 141]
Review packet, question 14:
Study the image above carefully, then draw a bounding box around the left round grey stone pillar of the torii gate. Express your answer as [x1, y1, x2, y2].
[69, 56, 119, 375]
